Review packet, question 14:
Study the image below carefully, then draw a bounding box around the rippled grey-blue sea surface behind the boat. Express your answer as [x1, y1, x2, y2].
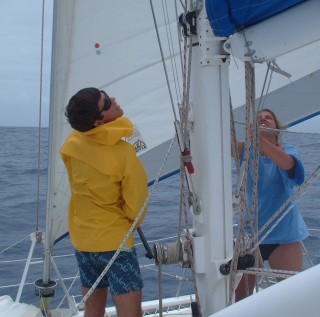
[0, 127, 320, 307]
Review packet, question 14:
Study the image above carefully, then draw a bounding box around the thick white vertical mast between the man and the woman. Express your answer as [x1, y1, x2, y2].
[190, 1, 233, 316]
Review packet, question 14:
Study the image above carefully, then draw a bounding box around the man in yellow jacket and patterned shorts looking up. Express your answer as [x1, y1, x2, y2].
[61, 88, 148, 317]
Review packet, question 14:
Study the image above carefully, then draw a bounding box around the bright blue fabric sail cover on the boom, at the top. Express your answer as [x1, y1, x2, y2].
[206, 0, 306, 36]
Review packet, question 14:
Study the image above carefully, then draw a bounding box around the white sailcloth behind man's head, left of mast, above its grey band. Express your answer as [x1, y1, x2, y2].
[48, 0, 181, 242]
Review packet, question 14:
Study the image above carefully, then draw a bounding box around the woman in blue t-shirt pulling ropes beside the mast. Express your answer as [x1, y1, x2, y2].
[236, 109, 308, 301]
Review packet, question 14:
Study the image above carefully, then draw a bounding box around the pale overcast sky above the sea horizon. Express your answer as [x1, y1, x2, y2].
[0, 0, 320, 132]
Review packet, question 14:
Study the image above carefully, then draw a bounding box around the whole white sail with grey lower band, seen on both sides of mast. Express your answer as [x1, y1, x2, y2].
[48, 0, 320, 242]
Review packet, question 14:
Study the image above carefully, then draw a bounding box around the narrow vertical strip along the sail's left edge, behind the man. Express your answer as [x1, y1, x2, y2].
[46, 0, 75, 247]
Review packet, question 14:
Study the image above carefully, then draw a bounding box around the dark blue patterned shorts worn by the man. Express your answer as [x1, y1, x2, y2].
[75, 248, 143, 295]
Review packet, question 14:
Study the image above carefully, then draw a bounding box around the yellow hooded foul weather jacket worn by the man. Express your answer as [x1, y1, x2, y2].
[61, 117, 148, 252]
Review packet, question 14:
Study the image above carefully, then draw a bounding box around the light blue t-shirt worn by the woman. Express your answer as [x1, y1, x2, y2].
[241, 145, 309, 244]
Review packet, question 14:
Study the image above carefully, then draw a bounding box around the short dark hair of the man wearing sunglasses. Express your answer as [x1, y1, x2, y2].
[65, 88, 101, 132]
